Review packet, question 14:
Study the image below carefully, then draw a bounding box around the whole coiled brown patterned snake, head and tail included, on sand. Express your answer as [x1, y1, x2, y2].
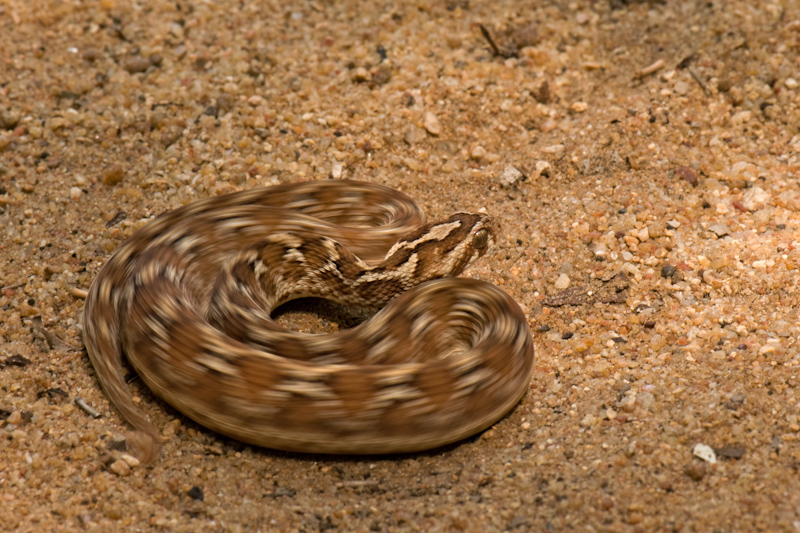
[85, 181, 533, 459]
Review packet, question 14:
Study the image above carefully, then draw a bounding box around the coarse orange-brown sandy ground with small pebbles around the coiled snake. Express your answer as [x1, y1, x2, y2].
[0, 0, 800, 531]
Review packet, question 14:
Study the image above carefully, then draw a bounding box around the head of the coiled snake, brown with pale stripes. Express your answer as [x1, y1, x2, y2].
[385, 213, 496, 282]
